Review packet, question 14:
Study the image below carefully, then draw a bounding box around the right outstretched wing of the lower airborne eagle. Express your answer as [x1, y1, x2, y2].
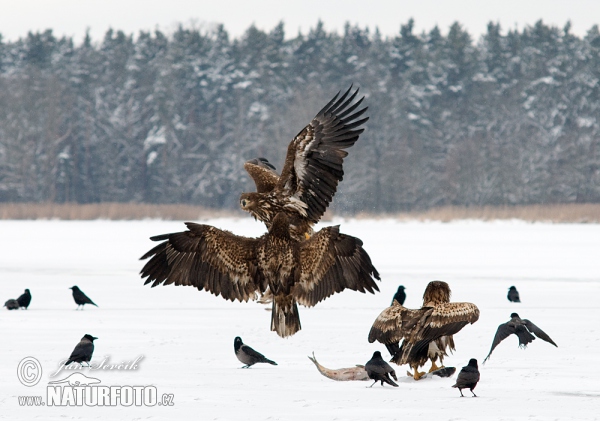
[293, 226, 380, 307]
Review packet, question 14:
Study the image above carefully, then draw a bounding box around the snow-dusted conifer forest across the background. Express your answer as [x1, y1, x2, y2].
[0, 20, 600, 213]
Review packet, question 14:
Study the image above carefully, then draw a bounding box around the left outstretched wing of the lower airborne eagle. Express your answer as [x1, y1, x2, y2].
[140, 222, 266, 301]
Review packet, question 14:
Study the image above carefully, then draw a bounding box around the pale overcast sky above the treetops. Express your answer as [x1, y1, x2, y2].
[0, 0, 600, 41]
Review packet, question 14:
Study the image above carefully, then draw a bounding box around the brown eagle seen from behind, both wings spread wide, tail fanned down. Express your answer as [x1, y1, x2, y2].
[140, 213, 380, 337]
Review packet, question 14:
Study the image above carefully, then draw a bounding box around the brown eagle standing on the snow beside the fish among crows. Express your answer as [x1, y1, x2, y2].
[369, 281, 479, 380]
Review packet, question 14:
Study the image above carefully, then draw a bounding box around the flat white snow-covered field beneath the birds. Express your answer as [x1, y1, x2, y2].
[0, 218, 600, 421]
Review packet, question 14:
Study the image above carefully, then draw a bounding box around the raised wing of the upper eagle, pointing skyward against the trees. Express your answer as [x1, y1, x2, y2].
[276, 86, 369, 223]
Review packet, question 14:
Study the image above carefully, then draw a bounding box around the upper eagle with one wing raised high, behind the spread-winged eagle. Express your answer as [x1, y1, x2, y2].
[240, 87, 369, 241]
